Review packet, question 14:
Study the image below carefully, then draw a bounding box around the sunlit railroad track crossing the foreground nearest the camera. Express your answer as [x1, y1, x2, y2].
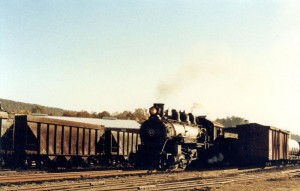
[2, 169, 300, 191]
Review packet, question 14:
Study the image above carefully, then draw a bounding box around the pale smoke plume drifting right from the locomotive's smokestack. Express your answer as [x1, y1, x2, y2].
[157, 43, 237, 100]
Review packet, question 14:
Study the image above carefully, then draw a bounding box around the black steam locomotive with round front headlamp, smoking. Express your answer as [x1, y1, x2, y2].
[135, 104, 224, 169]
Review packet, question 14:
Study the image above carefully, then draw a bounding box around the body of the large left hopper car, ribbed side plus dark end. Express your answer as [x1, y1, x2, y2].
[8, 115, 104, 167]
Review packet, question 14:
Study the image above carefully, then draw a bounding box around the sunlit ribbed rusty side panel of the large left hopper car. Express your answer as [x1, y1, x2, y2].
[28, 122, 103, 156]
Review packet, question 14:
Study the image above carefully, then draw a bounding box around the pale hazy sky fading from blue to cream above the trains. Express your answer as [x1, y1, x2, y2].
[0, 0, 300, 134]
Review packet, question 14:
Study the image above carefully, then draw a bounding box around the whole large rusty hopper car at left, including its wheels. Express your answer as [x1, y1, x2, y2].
[2, 115, 104, 168]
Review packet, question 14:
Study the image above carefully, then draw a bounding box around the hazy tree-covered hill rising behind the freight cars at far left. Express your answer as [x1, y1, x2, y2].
[0, 98, 68, 116]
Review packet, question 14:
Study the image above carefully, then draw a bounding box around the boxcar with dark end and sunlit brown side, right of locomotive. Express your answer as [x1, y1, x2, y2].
[237, 123, 289, 166]
